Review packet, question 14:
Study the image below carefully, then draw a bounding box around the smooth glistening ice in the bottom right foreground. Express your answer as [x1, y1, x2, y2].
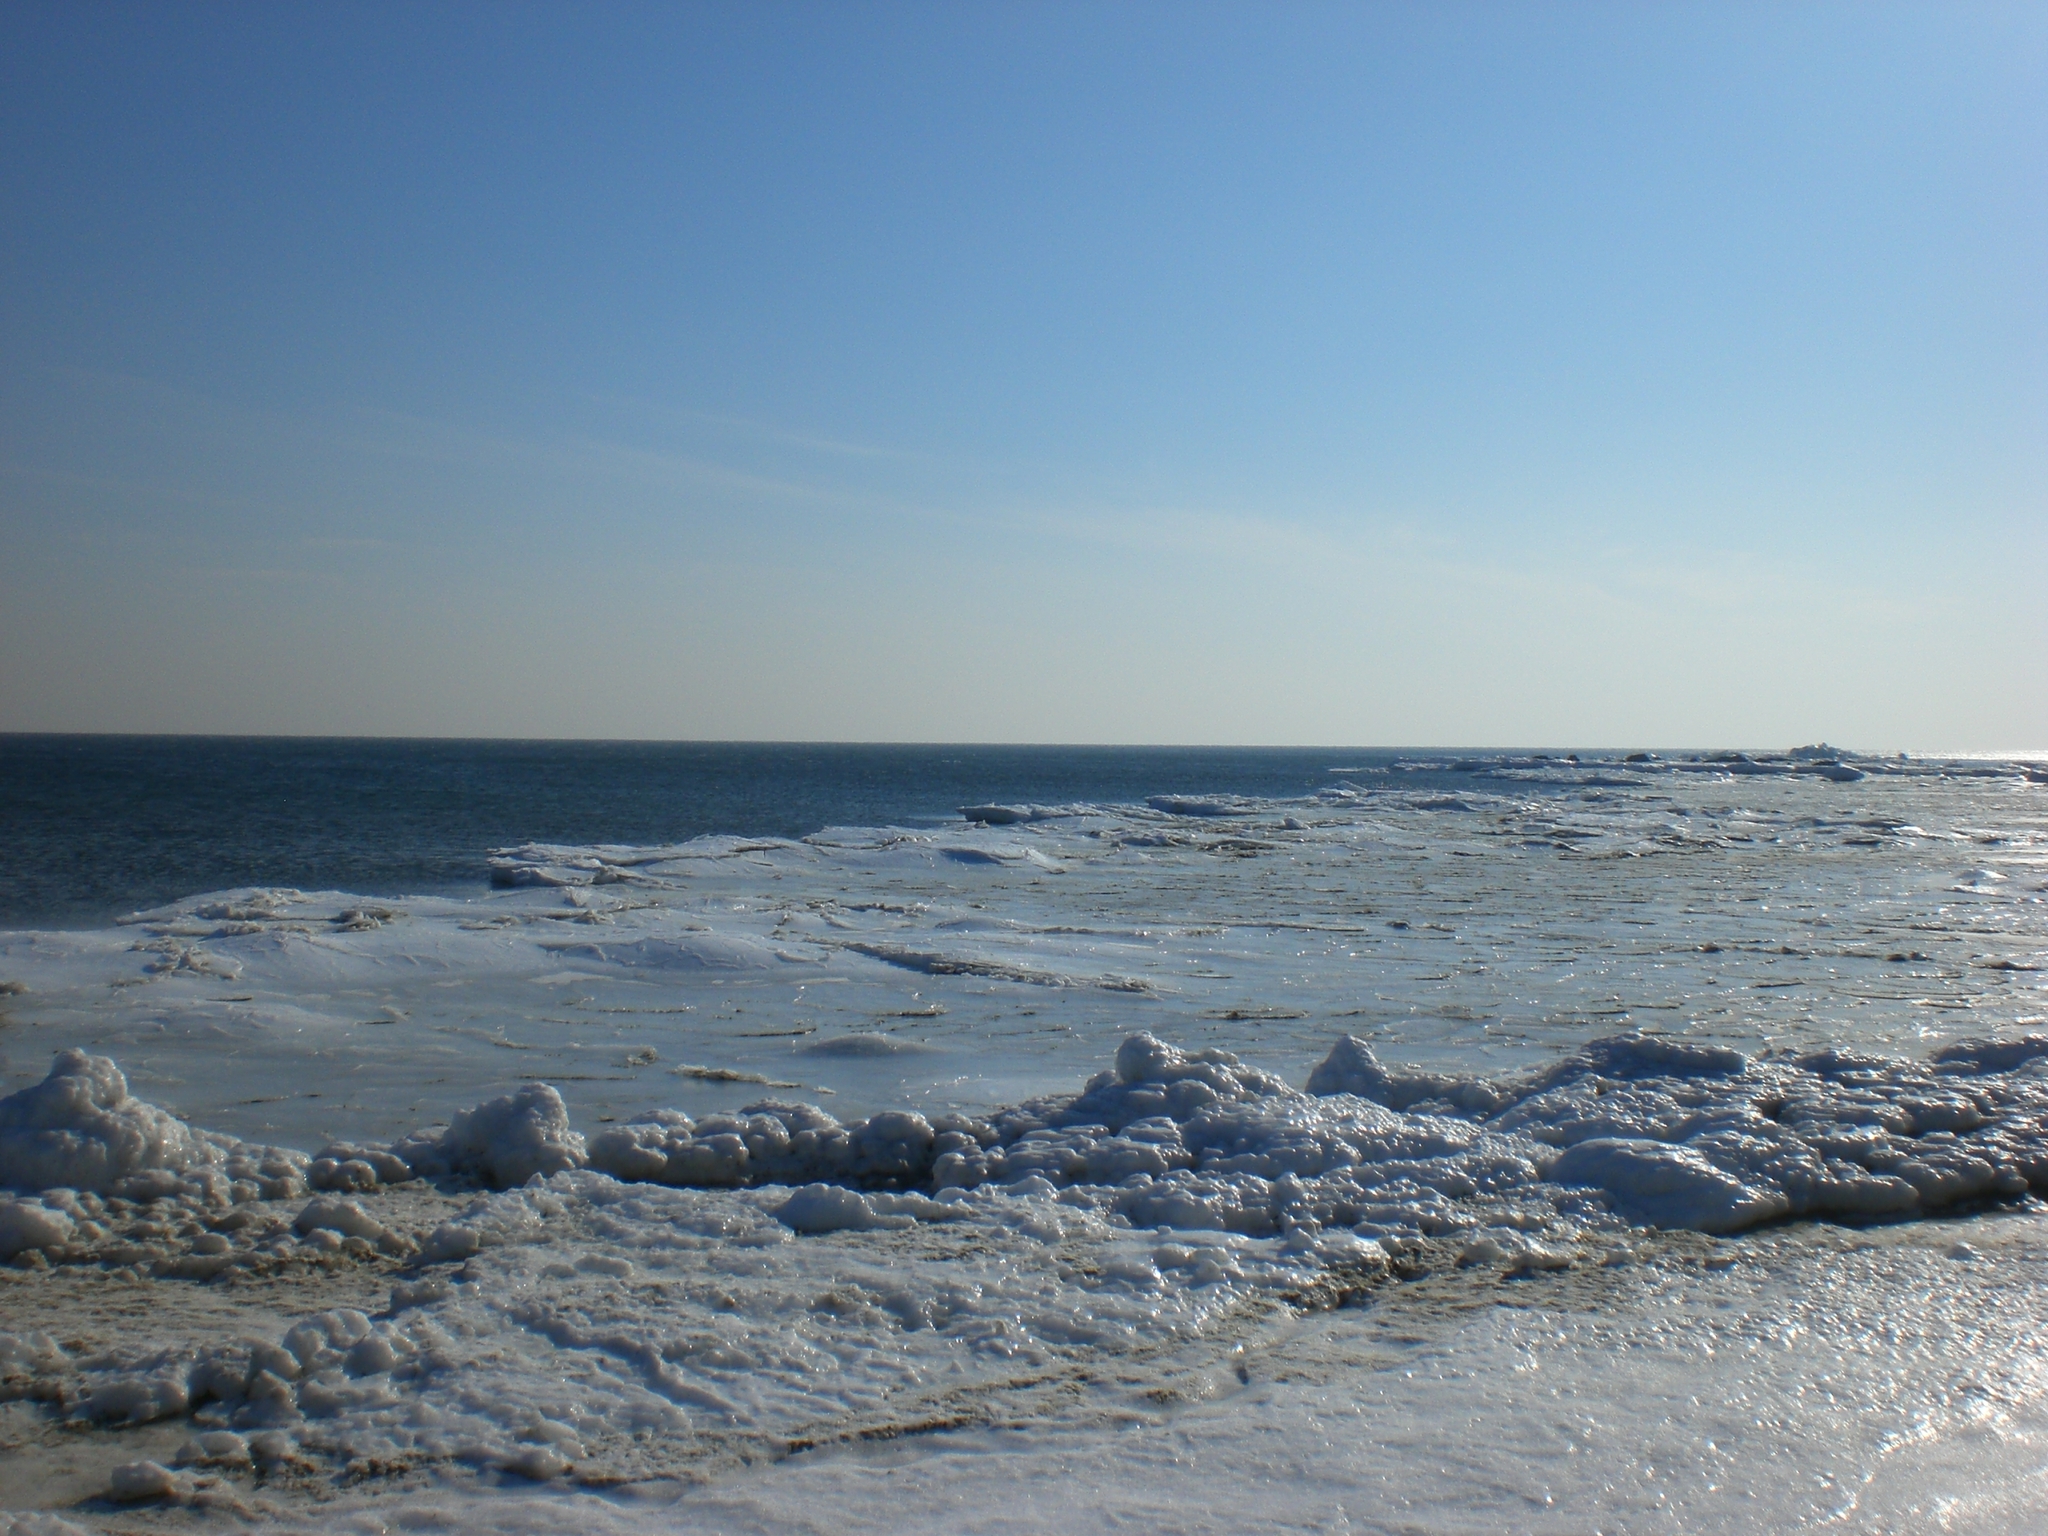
[292, 1229, 2048, 1536]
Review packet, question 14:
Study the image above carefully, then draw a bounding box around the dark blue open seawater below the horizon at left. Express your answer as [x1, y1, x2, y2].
[0, 735, 1393, 928]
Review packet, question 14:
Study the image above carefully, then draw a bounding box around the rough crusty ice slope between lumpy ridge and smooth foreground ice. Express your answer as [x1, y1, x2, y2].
[0, 1116, 1384, 1479]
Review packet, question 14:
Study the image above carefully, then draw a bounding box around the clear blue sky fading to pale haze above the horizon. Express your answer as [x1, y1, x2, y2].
[0, 0, 2048, 752]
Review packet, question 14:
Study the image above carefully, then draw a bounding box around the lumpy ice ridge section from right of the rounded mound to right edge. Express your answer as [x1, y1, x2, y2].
[569, 1034, 2048, 1237]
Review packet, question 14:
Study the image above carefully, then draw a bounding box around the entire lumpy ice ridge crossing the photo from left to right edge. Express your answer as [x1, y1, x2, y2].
[0, 1034, 2048, 1255]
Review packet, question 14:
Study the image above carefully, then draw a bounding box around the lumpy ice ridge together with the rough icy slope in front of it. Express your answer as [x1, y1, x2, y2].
[12, 1036, 2048, 1475]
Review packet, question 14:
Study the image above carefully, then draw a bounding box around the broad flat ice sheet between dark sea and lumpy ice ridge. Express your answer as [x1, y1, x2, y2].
[0, 743, 2048, 1171]
